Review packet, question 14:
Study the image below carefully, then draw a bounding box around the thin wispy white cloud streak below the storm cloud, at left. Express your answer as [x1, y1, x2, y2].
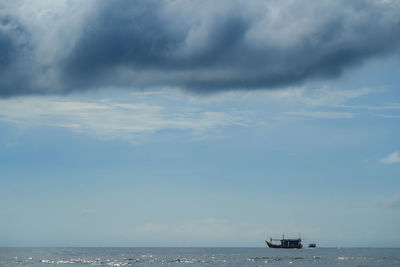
[0, 97, 246, 141]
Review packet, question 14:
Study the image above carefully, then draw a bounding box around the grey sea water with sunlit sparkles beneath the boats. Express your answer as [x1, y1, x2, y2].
[0, 248, 400, 267]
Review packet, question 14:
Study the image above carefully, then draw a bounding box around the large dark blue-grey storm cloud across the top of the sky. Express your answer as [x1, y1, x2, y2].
[0, 0, 400, 96]
